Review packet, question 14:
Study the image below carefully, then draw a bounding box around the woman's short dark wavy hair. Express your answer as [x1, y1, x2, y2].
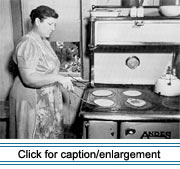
[30, 5, 58, 24]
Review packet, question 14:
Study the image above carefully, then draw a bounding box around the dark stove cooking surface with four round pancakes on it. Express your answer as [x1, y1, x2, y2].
[81, 86, 180, 120]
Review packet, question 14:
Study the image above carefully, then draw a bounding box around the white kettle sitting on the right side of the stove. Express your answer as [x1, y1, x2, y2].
[155, 68, 180, 96]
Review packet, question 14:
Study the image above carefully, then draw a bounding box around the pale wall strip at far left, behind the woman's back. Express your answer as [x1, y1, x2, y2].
[0, 0, 14, 101]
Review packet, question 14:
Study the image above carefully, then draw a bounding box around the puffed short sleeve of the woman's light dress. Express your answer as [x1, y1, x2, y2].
[15, 39, 39, 69]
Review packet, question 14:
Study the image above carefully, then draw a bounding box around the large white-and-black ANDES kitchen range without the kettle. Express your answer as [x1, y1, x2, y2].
[80, 6, 180, 139]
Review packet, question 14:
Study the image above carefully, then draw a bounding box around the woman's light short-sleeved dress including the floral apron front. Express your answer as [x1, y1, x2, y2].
[10, 32, 64, 139]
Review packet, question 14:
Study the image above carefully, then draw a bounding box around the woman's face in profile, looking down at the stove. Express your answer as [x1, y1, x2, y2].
[36, 17, 57, 38]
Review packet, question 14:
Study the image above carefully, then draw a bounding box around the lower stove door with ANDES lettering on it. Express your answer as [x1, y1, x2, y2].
[120, 122, 180, 139]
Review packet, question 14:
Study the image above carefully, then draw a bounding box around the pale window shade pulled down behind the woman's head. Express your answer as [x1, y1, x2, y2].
[21, 0, 80, 42]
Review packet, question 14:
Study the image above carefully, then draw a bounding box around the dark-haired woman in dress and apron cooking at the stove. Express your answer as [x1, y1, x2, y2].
[10, 6, 74, 139]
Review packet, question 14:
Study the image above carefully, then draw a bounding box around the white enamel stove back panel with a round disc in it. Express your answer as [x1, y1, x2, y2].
[91, 52, 172, 85]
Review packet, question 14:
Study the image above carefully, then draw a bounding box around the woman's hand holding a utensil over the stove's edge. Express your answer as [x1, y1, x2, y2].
[58, 76, 74, 91]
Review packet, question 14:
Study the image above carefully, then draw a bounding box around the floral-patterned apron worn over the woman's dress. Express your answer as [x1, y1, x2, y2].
[21, 35, 64, 139]
